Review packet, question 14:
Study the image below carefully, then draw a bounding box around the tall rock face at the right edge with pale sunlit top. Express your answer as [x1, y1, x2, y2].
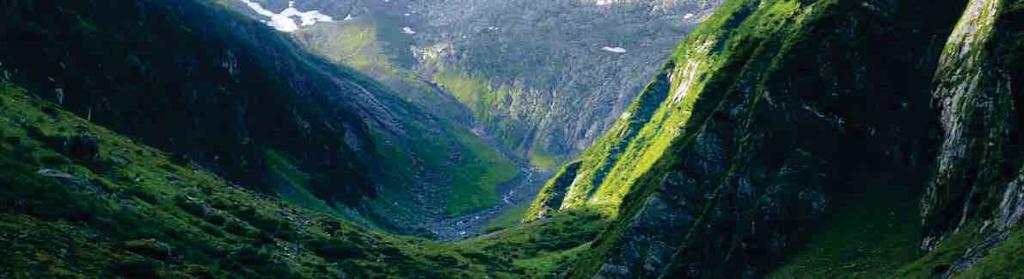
[922, 1, 1024, 240]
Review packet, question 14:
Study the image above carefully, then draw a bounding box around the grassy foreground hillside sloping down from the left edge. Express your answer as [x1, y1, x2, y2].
[0, 84, 603, 278]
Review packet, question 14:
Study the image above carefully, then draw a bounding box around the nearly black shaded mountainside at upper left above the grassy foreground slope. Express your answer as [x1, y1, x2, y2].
[0, 0, 375, 204]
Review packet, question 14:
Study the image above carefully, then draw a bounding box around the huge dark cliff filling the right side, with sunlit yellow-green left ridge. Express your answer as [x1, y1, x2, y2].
[527, 0, 1021, 278]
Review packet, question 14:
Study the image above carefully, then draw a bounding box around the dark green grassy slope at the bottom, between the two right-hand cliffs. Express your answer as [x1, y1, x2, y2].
[767, 178, 924, 278]
